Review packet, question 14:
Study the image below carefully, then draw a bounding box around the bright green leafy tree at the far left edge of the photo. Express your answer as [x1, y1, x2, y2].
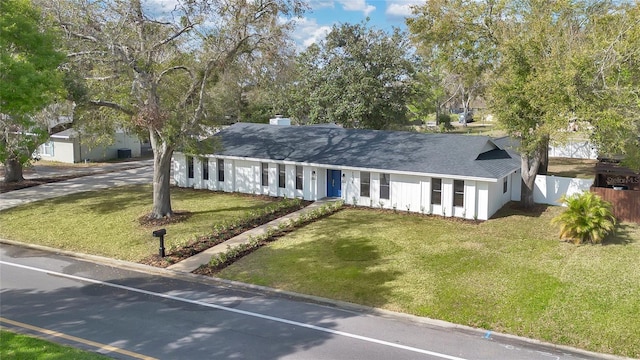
[0, 0, 65, 182]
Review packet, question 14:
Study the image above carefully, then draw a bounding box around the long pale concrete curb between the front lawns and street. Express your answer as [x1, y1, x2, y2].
[0, 238, 634, 360]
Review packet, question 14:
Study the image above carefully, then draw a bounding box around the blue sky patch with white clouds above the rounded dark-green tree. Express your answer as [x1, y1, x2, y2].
[293, 0, 425, 50]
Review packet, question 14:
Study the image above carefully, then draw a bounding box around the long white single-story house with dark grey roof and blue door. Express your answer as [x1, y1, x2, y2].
[173, 123, 520, 220]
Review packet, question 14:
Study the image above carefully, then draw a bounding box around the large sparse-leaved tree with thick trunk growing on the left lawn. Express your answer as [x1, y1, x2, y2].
[44, 0, 304, 218]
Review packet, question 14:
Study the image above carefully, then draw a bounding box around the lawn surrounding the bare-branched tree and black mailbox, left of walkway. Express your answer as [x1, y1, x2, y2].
[0, 185, 273, 261]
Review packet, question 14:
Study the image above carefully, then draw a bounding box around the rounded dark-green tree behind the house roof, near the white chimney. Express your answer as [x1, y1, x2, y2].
[288, 22, 414, 129]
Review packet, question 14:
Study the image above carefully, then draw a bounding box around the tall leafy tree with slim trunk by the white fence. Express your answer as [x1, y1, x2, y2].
[409, 0, 637, 207]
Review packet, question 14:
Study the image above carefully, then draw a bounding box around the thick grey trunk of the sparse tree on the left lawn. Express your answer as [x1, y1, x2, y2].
[149, 131, 173, 219]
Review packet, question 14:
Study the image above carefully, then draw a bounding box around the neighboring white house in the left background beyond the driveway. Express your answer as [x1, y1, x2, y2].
[36, 129, 140, 163]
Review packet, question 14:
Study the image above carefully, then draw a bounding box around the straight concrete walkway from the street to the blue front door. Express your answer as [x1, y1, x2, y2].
[167, 198, 340, 272]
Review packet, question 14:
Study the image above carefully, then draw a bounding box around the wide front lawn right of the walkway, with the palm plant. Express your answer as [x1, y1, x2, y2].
[218, 207, 640, 357]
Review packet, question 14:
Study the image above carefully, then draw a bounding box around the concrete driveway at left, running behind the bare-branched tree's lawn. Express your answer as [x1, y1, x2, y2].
[0, 160, 153, 211]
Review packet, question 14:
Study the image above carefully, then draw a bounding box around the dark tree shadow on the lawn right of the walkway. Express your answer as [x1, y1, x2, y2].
[214, 210, 401, 307]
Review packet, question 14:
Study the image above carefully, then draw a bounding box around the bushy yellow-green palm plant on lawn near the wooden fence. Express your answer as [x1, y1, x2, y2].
[551, 191, 616, 244]
